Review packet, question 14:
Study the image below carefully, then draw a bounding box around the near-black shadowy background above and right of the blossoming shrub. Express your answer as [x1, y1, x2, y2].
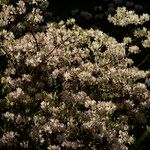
[44, 0, 150, 70]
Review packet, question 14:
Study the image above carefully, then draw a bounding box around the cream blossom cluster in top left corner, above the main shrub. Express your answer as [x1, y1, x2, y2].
[0, 0, 49, 37]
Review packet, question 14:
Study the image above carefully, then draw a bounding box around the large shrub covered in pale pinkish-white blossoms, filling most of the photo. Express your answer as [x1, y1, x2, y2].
[0, 0, 150, 150]
